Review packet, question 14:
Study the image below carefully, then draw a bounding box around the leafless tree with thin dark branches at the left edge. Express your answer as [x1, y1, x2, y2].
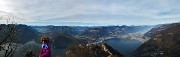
[0, 16, 18, 57]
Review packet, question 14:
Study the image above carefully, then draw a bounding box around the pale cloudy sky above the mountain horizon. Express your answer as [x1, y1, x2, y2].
[0, 0, 180, 26]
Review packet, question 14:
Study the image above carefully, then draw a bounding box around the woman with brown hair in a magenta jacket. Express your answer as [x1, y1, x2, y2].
[39, 36, 51, 57]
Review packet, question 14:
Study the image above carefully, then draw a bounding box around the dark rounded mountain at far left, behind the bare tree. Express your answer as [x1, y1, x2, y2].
[0, 24, 39, 44]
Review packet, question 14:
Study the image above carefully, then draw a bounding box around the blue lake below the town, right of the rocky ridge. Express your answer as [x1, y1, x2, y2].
[105, 38, 142, 56]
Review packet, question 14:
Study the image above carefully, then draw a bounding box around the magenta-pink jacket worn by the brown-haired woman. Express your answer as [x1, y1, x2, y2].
[39, 41, 51, 57]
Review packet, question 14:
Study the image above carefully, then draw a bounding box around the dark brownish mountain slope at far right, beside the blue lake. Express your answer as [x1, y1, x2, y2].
[131, 23, 180, 57]
